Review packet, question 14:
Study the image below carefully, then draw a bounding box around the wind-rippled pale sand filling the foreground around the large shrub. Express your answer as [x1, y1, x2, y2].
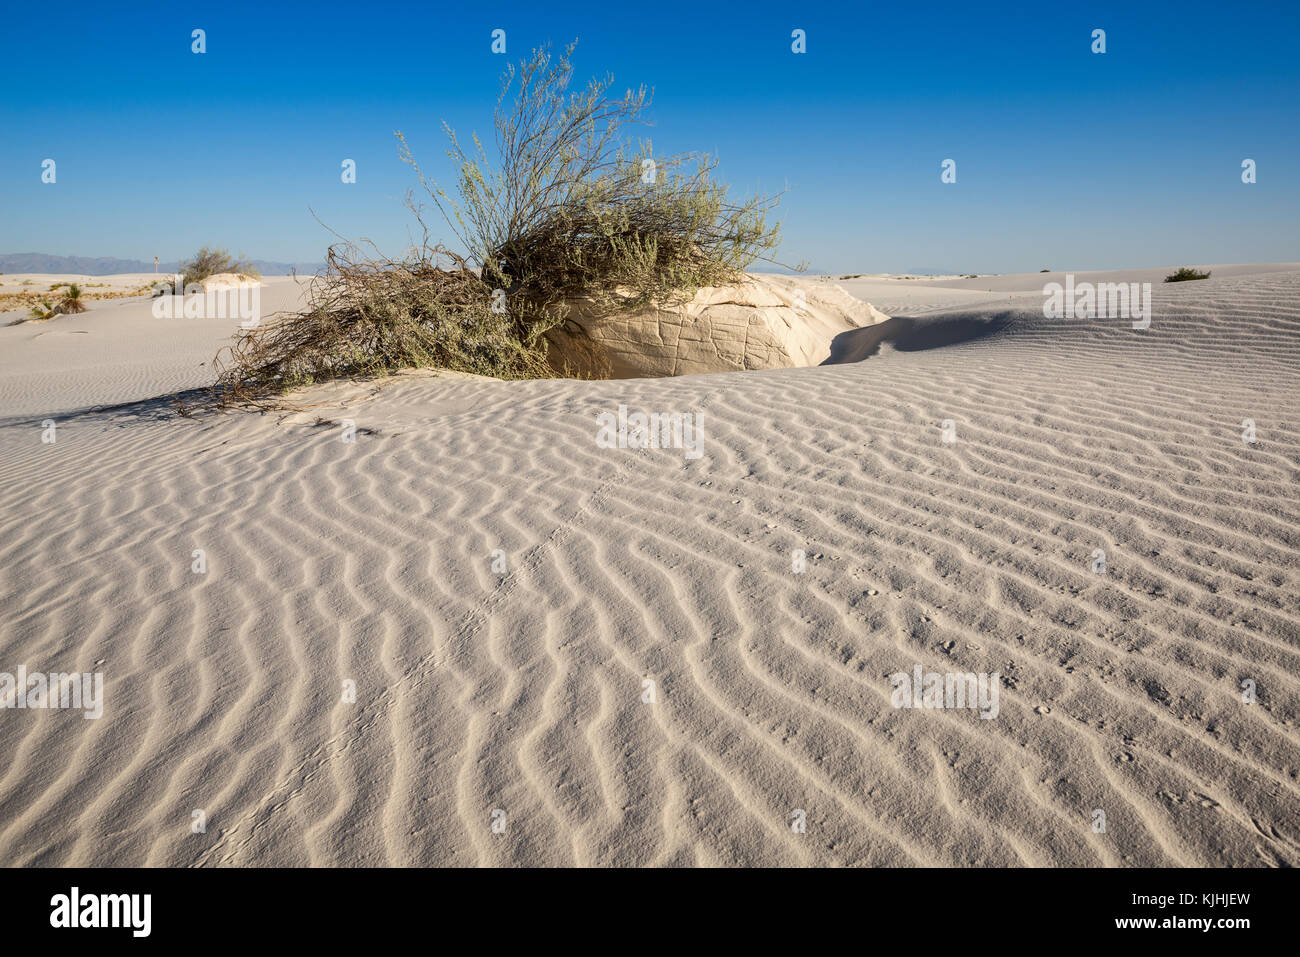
[0, 263, 1300, 866]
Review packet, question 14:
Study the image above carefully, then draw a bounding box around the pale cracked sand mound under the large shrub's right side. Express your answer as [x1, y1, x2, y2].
[551, 276, 888, 378]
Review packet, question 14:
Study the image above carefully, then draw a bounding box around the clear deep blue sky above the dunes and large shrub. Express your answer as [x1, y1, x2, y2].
[0, 0, 1300, 272]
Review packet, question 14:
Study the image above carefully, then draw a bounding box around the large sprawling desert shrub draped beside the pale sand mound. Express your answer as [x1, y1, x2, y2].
[209, 46, 779, 402]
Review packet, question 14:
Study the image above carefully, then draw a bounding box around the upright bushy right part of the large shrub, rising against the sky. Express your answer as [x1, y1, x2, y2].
[398, 44, 780, 330]
